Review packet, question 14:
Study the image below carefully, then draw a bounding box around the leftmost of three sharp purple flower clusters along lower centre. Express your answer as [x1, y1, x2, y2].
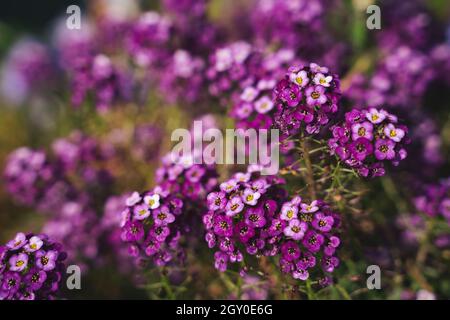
[121, 187, 187, 266]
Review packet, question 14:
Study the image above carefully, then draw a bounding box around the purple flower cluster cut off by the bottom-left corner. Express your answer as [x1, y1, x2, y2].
[0, 232, 66, 300]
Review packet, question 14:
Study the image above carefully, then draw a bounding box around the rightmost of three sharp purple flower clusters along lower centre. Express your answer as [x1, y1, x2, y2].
[278, 197, 341, 281]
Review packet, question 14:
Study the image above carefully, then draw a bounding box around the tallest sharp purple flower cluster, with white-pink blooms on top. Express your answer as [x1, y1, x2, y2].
[273, 63, 340, 136]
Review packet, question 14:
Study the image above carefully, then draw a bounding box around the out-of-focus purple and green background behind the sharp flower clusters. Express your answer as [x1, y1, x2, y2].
[0, 0, 450, 299]
